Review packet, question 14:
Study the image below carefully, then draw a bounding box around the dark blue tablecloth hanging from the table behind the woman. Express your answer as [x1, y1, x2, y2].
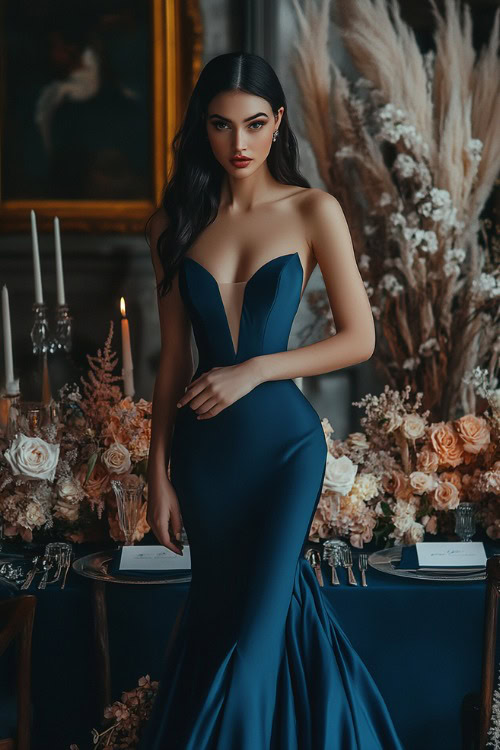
[1, 540, 500, 750]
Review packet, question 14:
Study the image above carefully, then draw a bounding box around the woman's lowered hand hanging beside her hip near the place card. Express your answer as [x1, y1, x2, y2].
[146, 475, 183, 555]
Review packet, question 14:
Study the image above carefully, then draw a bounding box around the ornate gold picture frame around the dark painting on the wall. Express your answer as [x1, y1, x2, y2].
[0, 0, 202, 233]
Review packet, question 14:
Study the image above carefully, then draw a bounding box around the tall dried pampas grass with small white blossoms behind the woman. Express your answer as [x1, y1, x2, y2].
[293, 0, 500, 420]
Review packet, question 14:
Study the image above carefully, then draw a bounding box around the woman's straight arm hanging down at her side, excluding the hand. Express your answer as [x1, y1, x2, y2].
[148, 209, 193, 478]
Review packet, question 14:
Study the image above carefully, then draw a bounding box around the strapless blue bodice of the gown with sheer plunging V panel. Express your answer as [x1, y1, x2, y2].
[179, 252, 304, 373]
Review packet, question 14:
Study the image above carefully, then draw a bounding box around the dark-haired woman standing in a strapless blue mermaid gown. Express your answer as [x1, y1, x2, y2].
[141, 53, 401, 750]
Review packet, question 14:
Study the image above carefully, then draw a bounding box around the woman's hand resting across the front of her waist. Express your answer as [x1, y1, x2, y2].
[177, 359, 262, 419]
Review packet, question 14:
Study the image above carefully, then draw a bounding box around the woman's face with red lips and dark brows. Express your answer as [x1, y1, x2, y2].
[206, 91, 285, 178]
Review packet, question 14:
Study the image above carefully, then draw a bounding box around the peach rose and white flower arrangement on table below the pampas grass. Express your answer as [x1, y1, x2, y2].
[309, 368, 500, 547]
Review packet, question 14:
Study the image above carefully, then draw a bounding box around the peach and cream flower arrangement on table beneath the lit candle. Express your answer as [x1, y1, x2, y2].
[0, 322, 152, 542]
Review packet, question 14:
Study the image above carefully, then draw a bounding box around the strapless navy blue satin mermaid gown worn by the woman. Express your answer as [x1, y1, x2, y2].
[140, 252, 402, 750]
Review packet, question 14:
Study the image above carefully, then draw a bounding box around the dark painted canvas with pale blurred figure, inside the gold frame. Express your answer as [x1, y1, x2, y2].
[1, 0, 153, 201]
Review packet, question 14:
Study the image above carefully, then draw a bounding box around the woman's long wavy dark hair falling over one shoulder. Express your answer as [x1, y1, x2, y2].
[146, 52, 311, 296]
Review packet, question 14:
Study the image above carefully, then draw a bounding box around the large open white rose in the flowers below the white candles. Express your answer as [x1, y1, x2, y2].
[4, 433, 59, 482]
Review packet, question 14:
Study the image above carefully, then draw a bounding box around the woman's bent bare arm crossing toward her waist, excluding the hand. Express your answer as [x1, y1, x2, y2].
[248, 190, 375, 382]
